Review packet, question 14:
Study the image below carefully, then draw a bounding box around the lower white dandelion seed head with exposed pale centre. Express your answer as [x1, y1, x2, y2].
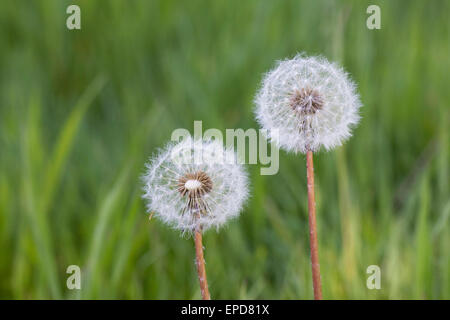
[143, 137, 248, 234]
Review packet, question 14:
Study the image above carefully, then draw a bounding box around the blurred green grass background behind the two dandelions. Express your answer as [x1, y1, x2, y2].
[0, 0, 450, 299]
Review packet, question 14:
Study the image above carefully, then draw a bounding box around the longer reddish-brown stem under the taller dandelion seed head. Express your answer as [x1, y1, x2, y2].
[306, 150, 322, 300]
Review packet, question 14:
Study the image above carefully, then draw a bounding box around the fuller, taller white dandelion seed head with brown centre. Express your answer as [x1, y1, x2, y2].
[255, 54, 361, 153]
